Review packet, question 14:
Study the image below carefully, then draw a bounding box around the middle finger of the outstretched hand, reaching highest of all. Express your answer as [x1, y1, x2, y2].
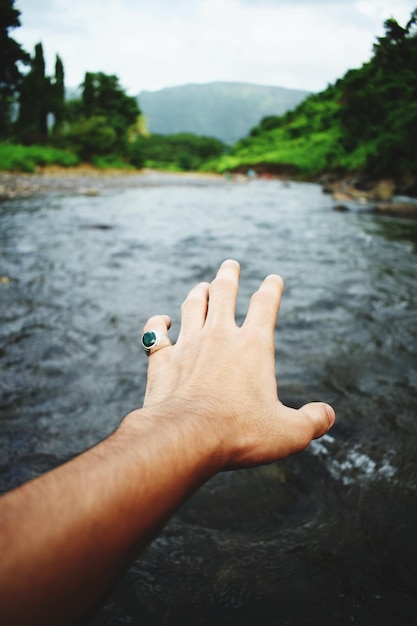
[207, 259, 240, 324]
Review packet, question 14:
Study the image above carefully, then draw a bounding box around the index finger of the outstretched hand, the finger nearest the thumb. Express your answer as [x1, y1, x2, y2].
[243, 274, 284, 331]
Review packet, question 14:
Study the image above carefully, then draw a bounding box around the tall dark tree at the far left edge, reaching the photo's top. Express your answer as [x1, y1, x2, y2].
[0, 0, 30, 139]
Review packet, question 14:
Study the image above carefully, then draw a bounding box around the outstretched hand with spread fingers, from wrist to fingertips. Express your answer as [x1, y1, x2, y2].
[138, 260, 335, 469]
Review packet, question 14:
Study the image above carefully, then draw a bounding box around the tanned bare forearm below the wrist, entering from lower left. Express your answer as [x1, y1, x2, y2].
[0, 409, 215, 625]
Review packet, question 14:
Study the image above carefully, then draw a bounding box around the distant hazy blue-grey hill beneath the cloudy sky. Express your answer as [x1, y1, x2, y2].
[138, 82, 309, 144]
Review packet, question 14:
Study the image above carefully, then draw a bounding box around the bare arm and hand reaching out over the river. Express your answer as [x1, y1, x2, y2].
[0, 260, 335, 626]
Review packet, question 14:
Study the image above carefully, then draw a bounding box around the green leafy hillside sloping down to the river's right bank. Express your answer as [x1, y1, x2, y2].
[216, 9, 417, 184]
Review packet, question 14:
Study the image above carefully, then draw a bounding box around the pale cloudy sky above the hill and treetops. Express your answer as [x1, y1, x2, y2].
[12, 0, 417, 95]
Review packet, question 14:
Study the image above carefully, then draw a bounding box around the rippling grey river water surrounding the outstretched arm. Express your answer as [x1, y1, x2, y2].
[0, 175, 417, 626]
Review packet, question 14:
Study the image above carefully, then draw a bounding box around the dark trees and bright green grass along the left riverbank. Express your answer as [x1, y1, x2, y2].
[0, 0, 225, 172]
